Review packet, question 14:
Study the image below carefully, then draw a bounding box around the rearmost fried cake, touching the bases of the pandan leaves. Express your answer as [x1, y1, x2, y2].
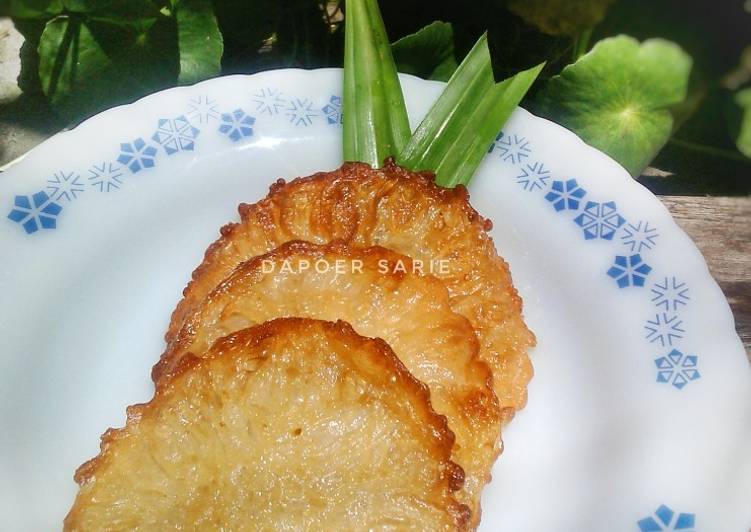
[166, 161, 534, 420]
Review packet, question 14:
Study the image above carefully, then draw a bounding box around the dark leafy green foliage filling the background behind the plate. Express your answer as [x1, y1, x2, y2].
[0, 0, 751, 194]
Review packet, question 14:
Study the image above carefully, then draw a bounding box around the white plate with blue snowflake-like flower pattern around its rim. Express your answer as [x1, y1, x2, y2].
[0, 70, 751, 532]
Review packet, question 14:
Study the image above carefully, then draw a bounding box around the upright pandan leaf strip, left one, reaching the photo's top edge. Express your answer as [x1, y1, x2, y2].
[342, 0, 410, 166]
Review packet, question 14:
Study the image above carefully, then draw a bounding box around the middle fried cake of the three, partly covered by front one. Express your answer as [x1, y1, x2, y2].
[155, 241, 500, 521]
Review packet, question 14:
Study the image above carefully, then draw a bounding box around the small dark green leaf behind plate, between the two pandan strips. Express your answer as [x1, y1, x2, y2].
[391, 21, 458, 81]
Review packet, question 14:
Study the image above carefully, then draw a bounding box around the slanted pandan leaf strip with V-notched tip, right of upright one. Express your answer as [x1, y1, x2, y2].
[398, 35, 543, 186]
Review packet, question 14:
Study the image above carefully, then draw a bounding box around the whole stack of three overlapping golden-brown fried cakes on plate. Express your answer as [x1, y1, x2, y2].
[65, 161, 534, 530]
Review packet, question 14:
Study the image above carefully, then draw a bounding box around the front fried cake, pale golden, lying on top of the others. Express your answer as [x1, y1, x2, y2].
[65, 318, 469, 531]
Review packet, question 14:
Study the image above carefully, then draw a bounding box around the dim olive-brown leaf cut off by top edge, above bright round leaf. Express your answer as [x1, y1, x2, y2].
[508, 0, 613, 37]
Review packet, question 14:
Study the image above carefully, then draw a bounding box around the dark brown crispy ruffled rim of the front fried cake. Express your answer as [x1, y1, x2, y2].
[64, 318, 472, 531]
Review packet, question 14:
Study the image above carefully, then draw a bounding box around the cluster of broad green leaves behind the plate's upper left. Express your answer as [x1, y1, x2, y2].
[5, 0, 223, 120]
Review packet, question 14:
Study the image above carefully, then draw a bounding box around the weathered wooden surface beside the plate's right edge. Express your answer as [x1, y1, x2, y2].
[660, 196, 751, 361]
